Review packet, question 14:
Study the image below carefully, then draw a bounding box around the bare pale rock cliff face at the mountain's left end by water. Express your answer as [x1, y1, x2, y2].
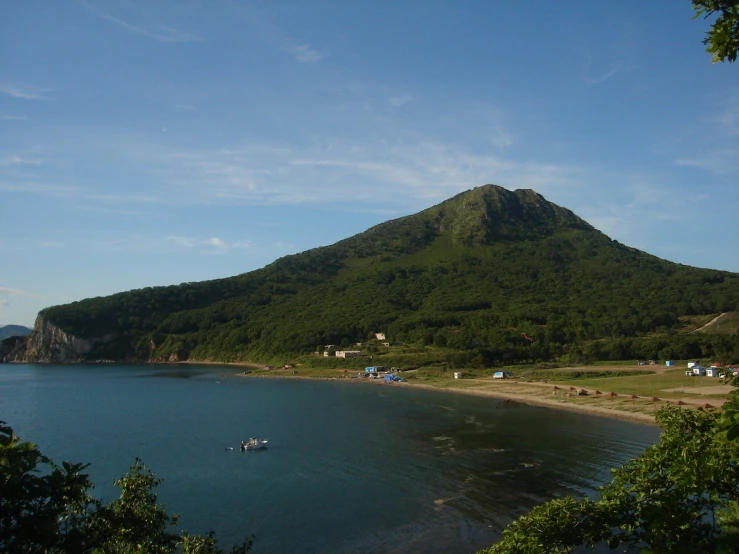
[7, 316, 112, 363]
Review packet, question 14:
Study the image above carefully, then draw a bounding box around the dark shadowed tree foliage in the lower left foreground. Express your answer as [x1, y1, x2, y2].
[0, 421, 252, 554]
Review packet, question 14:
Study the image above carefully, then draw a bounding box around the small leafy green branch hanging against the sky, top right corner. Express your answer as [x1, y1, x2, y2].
[692, 0, 739, 63]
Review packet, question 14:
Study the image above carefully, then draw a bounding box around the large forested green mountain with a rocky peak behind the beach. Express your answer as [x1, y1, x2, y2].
[14, 185, 739, 365]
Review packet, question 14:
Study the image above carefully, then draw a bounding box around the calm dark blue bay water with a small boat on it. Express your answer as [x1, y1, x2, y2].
[0, 365, 659, 554]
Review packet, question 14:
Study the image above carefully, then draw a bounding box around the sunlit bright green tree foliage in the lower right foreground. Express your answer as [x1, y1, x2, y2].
[483, 386, 739, 554]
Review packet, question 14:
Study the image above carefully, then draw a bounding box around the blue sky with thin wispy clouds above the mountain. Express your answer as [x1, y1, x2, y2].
[0, 0, 739, 325]
